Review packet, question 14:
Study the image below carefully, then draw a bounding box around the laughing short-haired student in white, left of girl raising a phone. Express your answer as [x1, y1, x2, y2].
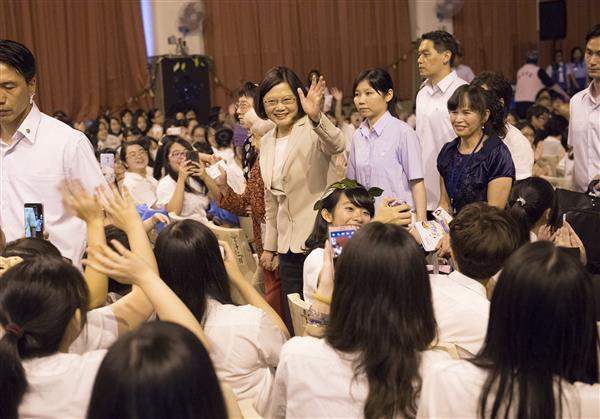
[121, 140, 158, 208]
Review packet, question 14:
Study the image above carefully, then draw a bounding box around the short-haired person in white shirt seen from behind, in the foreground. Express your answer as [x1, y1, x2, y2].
[430, 202, 521, 354]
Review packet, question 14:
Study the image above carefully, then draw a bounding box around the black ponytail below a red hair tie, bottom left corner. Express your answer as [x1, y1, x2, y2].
[0, 328, 27, 419]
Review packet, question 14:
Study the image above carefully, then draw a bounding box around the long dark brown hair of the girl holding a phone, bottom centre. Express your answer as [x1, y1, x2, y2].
[325, 222, 437, 418]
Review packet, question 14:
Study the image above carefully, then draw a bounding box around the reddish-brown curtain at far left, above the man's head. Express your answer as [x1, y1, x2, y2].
[0, 0, 149, 120]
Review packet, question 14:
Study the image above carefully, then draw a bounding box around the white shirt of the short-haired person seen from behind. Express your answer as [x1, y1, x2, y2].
[429, 271, 490, 354]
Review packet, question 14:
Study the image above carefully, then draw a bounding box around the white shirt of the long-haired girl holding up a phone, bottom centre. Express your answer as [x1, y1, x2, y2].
[265, 337, 449, 419]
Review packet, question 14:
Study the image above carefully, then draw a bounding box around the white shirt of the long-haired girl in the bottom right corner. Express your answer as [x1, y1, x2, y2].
[417, 360, 600, 419]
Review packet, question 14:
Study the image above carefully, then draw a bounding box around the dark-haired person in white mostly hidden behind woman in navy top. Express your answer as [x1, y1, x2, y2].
[472, 71, 533, 180]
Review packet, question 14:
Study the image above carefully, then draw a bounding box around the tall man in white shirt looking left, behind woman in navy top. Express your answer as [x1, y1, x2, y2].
[416, 31, 467, 211]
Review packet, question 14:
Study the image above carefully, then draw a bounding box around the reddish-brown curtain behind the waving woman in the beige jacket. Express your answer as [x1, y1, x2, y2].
[204, 0, 413, 105]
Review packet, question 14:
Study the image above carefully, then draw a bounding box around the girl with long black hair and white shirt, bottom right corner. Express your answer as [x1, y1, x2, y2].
[418, 242, 600, 419]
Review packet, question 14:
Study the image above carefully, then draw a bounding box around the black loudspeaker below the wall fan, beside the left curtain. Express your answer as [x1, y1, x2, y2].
[152, 55, 210, 124]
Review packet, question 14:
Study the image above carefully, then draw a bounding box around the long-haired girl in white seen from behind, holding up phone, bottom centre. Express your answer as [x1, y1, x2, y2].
[267, 222, 448, 418]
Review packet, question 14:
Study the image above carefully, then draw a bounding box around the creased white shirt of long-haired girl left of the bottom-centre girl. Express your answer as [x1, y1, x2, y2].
[203, 299, 286, 413]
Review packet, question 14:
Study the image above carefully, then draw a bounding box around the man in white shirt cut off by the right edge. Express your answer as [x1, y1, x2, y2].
[569, 25, 600, 192]
